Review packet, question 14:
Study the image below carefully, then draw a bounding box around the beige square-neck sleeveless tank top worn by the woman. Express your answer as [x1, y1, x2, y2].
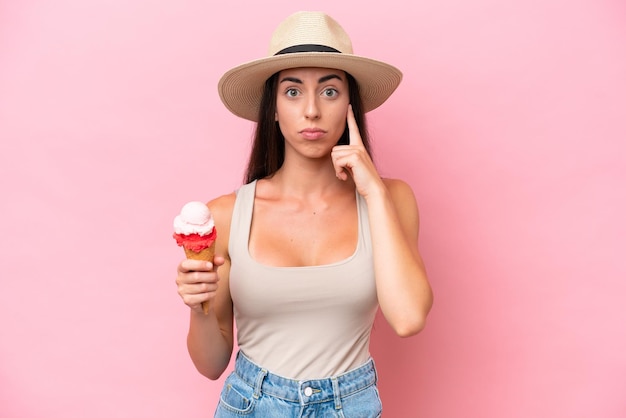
[228, 181, 378, 380]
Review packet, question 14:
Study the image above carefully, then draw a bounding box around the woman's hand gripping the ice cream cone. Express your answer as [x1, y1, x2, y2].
[176, 256, 224, 312]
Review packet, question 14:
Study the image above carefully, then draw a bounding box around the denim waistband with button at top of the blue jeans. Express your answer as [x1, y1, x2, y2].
[235, 352, 378, 407]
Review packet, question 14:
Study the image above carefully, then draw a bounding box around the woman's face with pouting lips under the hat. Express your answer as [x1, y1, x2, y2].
[275, 68, 350, 158]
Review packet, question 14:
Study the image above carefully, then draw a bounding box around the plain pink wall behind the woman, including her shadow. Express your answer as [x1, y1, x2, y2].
[0, 0, 626, 418]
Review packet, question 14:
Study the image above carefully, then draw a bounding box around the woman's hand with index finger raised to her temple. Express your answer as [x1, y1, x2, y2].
[331, 105, 384, 197]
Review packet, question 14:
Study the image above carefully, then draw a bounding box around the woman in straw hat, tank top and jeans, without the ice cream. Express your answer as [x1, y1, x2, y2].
[177, 12, 432, 418]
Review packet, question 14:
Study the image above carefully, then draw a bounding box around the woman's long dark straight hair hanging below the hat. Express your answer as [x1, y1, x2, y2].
[244, 73, 372, 184]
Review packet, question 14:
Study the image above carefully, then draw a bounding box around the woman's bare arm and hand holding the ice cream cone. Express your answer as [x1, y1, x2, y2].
[176, 194, 234, 380]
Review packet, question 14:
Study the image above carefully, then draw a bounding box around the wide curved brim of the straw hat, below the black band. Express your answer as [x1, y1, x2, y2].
[218, 52, 402, 122]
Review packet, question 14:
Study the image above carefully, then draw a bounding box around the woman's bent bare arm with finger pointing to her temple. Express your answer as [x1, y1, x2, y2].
[332, 107, 433, 337]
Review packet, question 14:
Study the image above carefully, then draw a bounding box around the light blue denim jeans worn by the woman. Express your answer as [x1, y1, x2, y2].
[215, 352, 382, 418]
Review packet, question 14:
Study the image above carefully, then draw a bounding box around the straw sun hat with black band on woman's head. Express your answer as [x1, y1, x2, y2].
[218, 12, 402, 121]
